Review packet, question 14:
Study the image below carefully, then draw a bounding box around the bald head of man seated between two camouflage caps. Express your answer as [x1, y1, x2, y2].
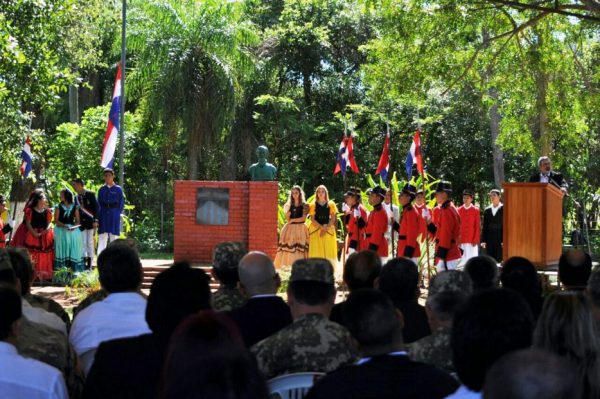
[238, 251, 280, 296]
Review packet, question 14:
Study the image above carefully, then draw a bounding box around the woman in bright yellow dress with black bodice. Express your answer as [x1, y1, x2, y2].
[308, 185, 338, 268]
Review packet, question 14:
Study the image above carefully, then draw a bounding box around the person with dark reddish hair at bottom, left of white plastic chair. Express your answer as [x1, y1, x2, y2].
[160, 311, 269, 399]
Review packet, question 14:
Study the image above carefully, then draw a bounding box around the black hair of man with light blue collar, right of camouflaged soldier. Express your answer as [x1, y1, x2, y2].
[342, 288, 402, 349]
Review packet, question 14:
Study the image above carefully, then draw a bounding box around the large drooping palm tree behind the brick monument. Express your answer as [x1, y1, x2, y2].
[128, 0, 256, 180]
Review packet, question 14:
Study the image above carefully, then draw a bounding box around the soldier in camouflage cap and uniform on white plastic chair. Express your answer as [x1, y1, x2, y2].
[251, 258, 356, 378]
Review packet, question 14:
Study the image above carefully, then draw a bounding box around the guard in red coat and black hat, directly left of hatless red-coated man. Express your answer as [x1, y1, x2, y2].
[425, 181, 461, 272]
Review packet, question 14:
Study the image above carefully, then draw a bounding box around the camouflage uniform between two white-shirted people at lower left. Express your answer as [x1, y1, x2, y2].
[16, 317, 84, 399]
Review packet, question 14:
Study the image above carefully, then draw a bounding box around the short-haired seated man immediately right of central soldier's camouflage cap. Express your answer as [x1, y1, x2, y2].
[329, 251, 381, 325]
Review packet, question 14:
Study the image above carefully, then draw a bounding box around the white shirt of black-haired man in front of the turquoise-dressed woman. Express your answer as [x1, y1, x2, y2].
[69, 292, 150, 372]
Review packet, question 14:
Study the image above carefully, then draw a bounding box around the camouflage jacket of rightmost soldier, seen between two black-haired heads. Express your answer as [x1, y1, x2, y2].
[407, 328, 456, 373]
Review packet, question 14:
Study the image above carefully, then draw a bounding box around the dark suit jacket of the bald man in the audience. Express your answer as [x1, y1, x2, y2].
[226, 296, 292, 348]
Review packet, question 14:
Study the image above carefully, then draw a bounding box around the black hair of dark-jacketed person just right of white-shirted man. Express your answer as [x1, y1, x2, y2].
[146, 262, 211, 336]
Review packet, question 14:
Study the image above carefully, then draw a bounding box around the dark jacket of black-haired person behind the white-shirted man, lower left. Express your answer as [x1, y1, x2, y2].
[83, 334, 169, 399]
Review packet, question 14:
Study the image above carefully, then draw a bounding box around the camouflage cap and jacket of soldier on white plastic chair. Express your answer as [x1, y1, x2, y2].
[251, 259, 356, 378]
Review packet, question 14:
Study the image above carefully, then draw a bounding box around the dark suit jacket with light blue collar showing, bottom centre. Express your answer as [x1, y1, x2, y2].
[305, 355, 459, 399]
